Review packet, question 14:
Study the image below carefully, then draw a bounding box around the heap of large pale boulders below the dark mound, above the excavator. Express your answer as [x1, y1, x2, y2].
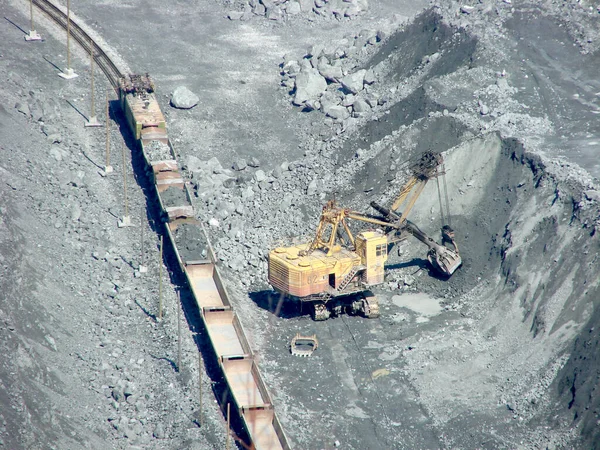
[281, 30, 385, 122]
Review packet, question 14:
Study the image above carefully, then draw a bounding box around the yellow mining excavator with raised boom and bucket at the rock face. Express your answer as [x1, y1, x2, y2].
[269, 152, 462, 320]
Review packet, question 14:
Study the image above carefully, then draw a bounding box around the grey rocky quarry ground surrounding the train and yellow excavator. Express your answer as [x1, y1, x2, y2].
[0, 0, 600, 449]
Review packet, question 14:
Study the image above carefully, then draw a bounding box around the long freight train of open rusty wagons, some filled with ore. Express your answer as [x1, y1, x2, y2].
[119, 74, 290, 450]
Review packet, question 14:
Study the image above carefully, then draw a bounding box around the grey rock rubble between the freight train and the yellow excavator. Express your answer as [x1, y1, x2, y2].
[184, 149, 336, 288]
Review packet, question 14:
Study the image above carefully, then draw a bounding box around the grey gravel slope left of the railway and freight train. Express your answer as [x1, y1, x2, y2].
[0, 1, 225, 449]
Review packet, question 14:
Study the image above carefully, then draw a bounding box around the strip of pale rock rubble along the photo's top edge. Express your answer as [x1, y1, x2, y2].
[227, 0, 369, 21]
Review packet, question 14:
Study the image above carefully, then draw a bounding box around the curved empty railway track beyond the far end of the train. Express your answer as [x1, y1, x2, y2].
[33, 0, 123, 92]
